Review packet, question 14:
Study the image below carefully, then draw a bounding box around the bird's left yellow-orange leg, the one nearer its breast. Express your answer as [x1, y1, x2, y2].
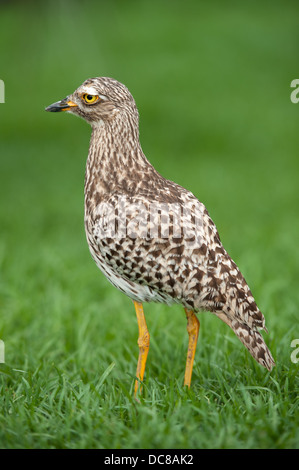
[134, 302, 150, 397]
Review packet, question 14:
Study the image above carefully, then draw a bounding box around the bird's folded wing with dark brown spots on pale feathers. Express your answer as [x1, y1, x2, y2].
[93, 184, 265, 328]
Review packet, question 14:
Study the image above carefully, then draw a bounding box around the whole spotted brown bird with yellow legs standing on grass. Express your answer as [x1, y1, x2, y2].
[45, 77, 275, 397]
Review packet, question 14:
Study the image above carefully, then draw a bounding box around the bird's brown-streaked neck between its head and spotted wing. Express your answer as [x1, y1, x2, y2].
[85, 114, 155, 207]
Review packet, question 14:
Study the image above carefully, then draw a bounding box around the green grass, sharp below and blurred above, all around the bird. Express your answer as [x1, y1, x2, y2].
[0, 0, 299, 449]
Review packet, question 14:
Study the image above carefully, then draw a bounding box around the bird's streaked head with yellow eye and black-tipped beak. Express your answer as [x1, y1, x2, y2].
[46, 77, 138, 126]
